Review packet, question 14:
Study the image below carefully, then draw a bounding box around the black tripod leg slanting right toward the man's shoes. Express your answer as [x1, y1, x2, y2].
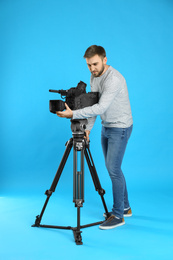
[84, 144, 109, 216]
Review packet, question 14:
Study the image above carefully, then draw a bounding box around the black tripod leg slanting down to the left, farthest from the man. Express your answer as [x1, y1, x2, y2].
[32, 138, 73, 227]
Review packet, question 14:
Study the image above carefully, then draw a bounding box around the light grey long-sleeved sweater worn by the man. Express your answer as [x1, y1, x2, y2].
[73, 66, 133, 130]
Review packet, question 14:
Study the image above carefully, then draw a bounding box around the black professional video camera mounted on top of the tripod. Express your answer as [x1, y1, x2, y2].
[49, 81, 99, 114]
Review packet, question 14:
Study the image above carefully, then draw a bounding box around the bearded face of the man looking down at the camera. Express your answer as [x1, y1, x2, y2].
[86, 55, 107, 77]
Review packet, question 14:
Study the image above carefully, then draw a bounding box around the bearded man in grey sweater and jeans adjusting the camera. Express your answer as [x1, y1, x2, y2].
[57, 45, 133, 229]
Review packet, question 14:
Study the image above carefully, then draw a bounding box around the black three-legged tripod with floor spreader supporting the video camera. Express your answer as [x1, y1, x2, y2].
[32, 119, 109, 245]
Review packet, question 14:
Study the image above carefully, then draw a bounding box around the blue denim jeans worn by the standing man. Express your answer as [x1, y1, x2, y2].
[101, 126, 133, 218]
